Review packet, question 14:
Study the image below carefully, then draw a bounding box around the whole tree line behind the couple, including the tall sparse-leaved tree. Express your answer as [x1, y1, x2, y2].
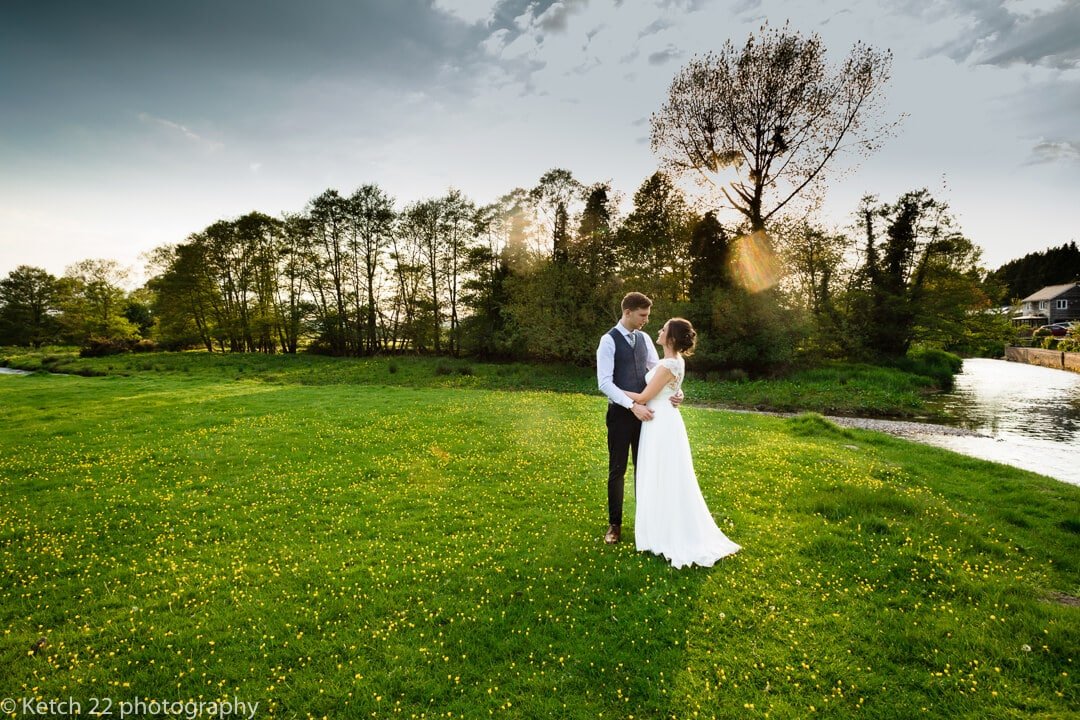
[0, 26, 1028, 372]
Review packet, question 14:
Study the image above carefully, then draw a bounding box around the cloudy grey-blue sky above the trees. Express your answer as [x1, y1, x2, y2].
[0, 0, 1080, 283]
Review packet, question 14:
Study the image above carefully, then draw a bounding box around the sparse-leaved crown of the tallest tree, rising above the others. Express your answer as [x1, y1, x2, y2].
[651, 25, 895, 233]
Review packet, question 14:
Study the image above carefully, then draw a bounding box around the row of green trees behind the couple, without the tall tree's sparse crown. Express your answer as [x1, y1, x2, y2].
[0, 168, 1002, 372]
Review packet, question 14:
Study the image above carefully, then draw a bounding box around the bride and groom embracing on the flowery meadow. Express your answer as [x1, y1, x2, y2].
[596, 293, 740, 568]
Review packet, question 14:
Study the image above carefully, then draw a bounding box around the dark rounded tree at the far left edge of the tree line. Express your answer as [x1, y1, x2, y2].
[0, 266, 58, 347]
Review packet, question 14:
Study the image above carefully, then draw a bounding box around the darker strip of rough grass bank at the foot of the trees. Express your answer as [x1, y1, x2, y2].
[0, 348, 935, 418]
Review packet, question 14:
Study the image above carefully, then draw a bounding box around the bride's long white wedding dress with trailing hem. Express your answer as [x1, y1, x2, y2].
[634, 357, 741, 568]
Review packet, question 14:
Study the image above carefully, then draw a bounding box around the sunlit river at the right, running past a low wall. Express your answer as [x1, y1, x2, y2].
[913, 358, 1080, 485]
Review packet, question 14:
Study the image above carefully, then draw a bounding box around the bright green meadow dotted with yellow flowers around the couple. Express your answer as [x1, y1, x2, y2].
[0, 355, 1080, 719]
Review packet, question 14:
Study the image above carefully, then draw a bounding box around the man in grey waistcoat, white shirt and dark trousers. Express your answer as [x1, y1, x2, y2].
[596, 293, 683, 545]
